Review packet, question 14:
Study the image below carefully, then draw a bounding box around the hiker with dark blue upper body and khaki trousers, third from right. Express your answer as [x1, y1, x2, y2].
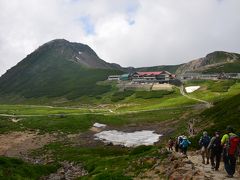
[199, 131, 211, 164]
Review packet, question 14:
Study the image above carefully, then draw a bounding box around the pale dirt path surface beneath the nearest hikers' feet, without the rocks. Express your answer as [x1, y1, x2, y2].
[188, 153, 240, 180]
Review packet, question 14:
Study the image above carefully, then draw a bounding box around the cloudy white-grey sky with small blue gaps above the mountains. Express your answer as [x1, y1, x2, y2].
[0, 0, 240, 75]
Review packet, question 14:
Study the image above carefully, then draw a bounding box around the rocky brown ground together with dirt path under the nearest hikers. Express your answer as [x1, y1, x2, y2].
[135, 152, 240, 180]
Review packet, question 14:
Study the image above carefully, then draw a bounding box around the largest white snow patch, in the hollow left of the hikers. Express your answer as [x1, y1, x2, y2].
[95, 130, 162, 147]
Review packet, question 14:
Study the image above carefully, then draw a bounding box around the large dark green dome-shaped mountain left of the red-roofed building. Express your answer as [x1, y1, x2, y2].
[0, 39, 122, 99]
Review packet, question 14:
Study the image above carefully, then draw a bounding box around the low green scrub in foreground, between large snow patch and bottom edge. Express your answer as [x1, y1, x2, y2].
[31, 143, 167, 179]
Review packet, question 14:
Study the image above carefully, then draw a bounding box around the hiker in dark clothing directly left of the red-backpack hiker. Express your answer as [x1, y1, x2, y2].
[207, 131, 222, 171]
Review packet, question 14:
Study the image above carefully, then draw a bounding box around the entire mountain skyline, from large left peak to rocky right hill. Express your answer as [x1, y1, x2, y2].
[0, 39, 240, 101]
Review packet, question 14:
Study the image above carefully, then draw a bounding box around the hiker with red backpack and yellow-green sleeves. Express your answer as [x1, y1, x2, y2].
[221, 126, 240, 178]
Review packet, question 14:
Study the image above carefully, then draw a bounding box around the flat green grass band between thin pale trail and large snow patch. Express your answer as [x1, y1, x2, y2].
[0, 108, 186, 134]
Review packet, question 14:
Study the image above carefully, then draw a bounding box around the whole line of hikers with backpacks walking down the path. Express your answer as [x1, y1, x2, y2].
[168, 126, 240, 178]
